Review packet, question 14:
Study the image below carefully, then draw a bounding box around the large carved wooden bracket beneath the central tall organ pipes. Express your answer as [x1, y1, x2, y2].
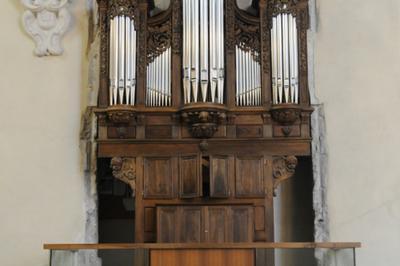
[181, 104, 226, 138]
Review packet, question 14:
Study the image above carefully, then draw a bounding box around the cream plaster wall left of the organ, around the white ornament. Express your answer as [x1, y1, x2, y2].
[0, 0, 87, 266]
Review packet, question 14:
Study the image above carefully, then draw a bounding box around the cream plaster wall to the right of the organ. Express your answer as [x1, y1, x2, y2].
[315, 0, 400, 266]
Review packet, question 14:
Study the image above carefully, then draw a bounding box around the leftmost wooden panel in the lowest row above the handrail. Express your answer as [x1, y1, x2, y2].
[157, 207, 178, 243]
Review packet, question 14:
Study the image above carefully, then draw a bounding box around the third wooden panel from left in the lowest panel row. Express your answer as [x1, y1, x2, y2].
[205, 206, 229, 243]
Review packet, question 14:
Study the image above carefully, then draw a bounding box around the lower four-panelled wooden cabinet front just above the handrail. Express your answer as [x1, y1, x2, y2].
[157, 205, 254, 243]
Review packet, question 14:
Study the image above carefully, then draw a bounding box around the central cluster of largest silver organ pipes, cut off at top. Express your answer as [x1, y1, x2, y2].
[183, 0, 225, 104]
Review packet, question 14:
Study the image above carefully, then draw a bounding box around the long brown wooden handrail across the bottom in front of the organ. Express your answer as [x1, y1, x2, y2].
[43, 242, 361, 250]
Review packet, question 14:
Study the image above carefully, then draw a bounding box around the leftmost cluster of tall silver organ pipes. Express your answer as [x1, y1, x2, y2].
[109, 16, 136, 106]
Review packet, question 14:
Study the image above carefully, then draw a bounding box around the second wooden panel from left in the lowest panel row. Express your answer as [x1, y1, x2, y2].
[177, 207, 203, 243]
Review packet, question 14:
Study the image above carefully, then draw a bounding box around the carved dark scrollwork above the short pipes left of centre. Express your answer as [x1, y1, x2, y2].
[147, 19, 172, 62]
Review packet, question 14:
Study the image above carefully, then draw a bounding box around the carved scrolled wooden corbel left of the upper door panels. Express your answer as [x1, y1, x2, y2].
[111, 157, 136, 197]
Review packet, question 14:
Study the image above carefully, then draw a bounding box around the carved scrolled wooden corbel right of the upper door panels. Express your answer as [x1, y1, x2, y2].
[272, 156, 297, 196]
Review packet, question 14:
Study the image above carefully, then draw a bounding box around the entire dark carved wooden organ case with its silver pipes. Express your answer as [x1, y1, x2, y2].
[96, 0, 312, 246]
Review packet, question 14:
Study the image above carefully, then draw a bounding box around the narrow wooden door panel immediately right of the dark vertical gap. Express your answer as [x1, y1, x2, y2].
[210, 156, 229, 198]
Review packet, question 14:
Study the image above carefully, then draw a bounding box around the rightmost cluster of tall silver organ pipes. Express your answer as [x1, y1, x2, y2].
[271, 14, 299, 104]
